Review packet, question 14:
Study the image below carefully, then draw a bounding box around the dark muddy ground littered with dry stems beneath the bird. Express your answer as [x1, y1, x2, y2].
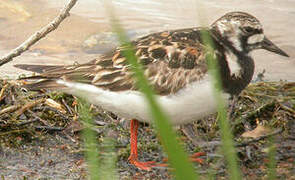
[0, 80, 295, 179]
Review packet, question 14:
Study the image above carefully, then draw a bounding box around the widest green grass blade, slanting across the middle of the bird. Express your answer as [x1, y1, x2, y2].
[107, 2, 198, 180]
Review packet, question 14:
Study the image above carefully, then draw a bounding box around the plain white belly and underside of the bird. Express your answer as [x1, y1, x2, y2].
[58, 78, 229, 124]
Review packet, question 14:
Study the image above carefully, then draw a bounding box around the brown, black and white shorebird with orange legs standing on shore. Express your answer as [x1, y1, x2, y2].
[15, 11, 289, 170]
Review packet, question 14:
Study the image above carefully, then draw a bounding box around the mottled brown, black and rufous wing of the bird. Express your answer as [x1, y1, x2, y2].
[20, 29, 207, 95]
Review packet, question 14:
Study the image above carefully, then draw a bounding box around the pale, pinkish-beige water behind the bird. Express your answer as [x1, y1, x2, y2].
[0, 0, 295, 81]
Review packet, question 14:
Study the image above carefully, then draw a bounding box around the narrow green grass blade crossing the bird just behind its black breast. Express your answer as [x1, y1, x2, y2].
[202, 30, 241, 180]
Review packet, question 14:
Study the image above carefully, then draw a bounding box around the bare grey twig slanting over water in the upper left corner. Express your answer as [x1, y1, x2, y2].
[0, 0, 77, 66]
